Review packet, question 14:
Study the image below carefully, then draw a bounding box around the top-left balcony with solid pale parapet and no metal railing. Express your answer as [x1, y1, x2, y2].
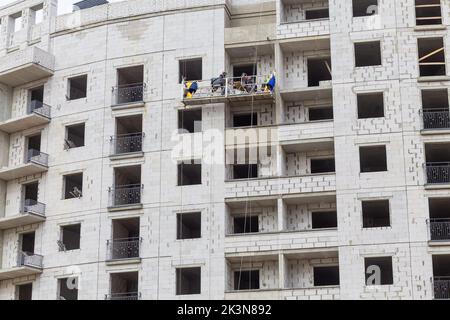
[0, 47, 55, 87]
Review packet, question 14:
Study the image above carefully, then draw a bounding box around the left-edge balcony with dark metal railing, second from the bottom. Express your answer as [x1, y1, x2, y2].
[0, 199, 45, 230]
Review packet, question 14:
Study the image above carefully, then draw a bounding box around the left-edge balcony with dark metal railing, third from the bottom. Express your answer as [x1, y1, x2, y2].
[0, 149, 48, 181]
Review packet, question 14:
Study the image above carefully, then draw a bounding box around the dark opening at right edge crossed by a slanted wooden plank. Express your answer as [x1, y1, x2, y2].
[417, 38, 447, 77]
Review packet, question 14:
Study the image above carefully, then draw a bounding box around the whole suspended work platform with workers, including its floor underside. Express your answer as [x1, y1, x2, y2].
[182, 76, 274, 106]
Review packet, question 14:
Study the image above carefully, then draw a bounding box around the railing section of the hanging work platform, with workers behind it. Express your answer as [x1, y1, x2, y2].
[183, 76, 273, 100]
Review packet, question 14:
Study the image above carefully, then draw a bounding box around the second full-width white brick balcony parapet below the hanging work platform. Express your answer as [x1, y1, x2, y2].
[225, 174, 336, 198]
